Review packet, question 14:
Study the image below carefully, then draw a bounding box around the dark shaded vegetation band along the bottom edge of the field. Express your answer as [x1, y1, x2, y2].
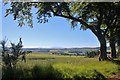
[2, 66, 106, 80]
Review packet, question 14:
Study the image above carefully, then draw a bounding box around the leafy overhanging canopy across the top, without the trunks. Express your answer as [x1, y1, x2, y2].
[5, 2, 120, 33]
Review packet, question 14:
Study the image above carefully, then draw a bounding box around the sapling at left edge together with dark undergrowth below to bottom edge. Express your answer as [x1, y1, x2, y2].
[1, 38, 22, 80]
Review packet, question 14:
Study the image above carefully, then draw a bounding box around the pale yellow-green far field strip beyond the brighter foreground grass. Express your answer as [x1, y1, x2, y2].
[18, 53, 91, 66]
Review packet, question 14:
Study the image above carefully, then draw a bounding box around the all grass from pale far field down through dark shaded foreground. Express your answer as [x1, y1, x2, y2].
[1, 53, 120, 80]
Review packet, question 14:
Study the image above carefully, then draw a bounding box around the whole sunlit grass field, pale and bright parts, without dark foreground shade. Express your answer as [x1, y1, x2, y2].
[12, 53, 120, 79]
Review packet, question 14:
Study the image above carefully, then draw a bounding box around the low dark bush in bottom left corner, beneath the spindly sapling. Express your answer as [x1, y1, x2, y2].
[2, 67, 32, 80]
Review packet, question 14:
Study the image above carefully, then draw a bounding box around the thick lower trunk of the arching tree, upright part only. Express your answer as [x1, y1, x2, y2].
[99, 38, 107, 61]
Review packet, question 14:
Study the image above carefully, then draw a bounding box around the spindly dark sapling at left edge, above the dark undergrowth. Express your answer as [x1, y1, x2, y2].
[1, 38, 22, 68]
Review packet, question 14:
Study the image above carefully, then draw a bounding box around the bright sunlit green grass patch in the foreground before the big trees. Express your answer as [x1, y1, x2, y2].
[53, 60, 118, 77]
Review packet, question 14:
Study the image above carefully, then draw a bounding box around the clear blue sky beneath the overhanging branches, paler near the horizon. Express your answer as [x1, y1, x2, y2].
[0, 4, 99, 48]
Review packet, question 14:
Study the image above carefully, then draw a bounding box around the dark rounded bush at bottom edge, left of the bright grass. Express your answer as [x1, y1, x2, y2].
[32, 66, 63, 80]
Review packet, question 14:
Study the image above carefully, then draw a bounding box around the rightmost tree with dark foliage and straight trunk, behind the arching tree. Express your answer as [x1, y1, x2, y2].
[101, 3, 120, 58]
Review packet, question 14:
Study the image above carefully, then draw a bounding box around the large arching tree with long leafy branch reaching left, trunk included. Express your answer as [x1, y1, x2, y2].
[5, 2, 120, 60]
